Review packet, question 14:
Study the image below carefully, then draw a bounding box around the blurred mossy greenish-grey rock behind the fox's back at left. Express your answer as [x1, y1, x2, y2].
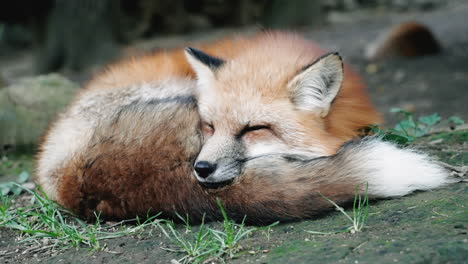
[0, 74, 79, 146]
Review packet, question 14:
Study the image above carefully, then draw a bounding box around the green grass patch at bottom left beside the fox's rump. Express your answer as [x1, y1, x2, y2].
[0, 185, 163, 250]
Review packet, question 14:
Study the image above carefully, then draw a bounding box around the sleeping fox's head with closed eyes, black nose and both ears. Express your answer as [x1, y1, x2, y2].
[185, 48, 343, 188]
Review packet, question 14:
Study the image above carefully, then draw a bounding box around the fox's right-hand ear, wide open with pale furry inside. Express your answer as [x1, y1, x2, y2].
[288, 52, 343, 118]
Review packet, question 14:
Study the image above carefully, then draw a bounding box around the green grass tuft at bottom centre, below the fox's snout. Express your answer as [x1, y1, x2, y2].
[159, 199, 278, 263]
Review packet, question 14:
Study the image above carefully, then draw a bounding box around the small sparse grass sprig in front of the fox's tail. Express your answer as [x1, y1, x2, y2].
[306, 185, 369, 235]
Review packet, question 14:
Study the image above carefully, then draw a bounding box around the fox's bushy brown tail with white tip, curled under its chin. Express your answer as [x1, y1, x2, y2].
[220, 137, 452, 223]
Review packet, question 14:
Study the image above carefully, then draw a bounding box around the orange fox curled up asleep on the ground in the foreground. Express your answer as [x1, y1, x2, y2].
[35, 31, 451, 225]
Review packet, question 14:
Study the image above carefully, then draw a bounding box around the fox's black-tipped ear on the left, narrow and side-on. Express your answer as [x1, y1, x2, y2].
[185, 47, 225, 87]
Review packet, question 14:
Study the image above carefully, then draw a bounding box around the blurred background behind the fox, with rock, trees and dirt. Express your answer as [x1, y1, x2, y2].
[0, 0, 468, 148]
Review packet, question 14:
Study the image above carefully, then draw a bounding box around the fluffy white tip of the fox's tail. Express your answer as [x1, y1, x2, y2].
[348, 138, 452, 197]
